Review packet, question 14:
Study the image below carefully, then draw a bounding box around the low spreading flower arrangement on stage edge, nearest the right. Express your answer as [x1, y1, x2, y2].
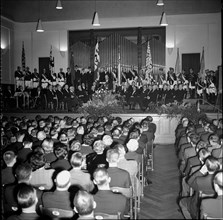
[155, 102, 207, 124]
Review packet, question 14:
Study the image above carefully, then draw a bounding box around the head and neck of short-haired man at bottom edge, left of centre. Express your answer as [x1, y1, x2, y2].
[73, 190, 97, 220]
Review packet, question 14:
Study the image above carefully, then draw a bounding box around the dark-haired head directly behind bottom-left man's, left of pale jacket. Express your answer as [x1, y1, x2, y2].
[15, 163, 32, 182]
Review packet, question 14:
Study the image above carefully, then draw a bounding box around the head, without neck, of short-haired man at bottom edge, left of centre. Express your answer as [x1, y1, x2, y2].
[74, 190, 95, 216]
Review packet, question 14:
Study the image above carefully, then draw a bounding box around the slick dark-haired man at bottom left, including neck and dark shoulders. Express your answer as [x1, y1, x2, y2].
[7, 183, 47, 220]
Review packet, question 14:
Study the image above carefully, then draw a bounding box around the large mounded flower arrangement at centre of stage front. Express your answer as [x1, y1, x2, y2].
[78, 89, 123, 117]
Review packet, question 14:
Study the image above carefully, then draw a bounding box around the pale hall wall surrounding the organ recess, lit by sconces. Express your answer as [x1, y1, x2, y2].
[2, 13, 221, 83]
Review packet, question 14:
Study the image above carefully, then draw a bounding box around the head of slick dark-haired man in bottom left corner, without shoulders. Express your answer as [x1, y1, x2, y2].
[17, 183, 38, 209]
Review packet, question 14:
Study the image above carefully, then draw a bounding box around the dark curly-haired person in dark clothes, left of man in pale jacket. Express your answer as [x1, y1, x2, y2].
[50, 142, 71, 170]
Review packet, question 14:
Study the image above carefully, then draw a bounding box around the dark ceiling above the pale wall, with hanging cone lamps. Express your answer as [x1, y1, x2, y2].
[1, 0, 222, 22]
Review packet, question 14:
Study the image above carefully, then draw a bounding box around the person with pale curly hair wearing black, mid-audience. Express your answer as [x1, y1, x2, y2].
[86, 140, 108, 174]
